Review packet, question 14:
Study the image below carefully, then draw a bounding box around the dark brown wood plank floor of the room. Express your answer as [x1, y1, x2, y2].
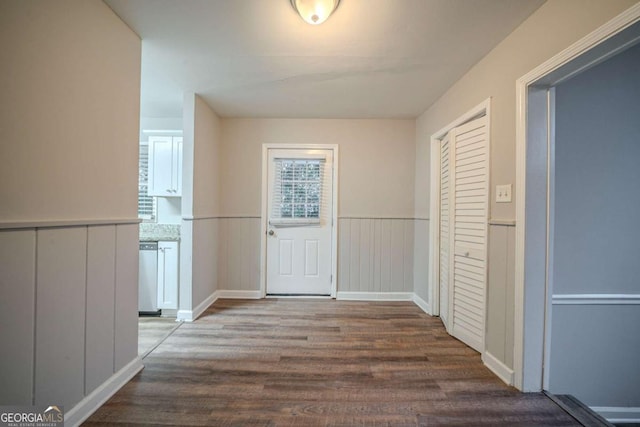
[85, 299, 578, 426]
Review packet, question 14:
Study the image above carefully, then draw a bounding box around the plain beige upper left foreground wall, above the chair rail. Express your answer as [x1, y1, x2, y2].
[0, 0, 140, 222]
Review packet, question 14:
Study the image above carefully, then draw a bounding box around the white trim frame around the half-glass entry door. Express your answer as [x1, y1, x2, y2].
[260, 144, 339, 298]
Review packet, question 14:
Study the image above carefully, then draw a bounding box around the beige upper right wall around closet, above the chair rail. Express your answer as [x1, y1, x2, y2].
[415, 0, 637, 219]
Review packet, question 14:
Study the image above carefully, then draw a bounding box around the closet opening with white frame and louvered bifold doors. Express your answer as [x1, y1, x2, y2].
[429, 99, 491, 353]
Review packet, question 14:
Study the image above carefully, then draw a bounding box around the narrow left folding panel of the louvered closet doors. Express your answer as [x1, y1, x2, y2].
[439, 135, 450, 328]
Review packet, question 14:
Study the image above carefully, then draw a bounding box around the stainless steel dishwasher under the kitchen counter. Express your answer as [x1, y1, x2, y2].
[138, 242, 160, 316]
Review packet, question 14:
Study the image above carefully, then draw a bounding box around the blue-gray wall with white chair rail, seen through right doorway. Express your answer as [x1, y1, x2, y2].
[549, 41, 640, 407]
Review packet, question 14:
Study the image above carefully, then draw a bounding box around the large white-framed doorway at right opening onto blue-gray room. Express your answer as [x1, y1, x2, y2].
[514, 5, 640, 422]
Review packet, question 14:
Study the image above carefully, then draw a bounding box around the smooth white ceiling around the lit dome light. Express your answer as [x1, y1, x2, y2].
[105, 0, 544, 118]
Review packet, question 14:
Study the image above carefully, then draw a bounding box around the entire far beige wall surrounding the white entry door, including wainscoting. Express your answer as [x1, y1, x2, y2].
[218, 119, 415, 292]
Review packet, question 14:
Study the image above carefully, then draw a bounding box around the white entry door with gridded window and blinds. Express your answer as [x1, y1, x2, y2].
[266, 149, 333, 295]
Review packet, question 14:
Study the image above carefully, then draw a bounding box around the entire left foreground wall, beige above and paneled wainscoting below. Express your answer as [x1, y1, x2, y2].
[0, 0, 142, 416]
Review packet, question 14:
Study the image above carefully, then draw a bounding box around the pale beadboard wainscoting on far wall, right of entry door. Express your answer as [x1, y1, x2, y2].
[338, 218, 415, 295]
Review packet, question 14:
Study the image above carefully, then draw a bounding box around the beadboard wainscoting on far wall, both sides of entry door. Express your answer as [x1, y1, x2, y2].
[218, 217, 415, 299]
